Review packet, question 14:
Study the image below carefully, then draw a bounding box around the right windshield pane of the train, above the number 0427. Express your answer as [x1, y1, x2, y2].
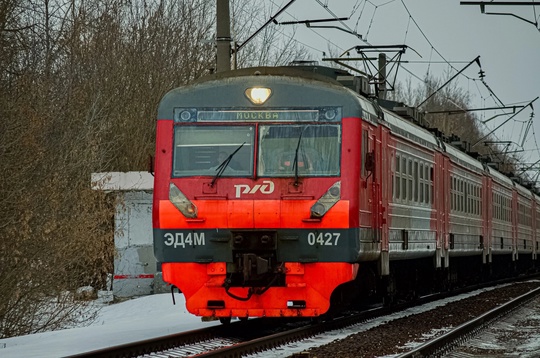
[257, 124, 341, 177]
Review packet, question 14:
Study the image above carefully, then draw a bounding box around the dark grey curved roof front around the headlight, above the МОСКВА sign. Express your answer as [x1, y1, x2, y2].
[158, 67, 367, 119]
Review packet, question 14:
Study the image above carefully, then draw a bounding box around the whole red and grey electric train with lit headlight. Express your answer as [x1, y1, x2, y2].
[153, 66, 540, 321]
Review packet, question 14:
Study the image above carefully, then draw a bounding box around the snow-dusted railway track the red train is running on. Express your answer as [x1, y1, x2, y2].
[67, 281, 538, 357]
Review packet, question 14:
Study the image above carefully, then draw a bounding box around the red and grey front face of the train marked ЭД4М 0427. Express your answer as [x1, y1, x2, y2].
[153, 69, 372, 317]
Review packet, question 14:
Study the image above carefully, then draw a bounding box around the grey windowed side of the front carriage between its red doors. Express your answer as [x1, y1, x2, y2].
[384, 107, 441, 260]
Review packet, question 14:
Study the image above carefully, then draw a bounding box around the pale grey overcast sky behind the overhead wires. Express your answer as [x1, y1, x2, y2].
[256, 0, 540, 176]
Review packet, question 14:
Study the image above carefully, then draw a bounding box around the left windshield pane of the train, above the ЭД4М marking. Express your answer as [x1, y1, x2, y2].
[173, 126, 255, 177]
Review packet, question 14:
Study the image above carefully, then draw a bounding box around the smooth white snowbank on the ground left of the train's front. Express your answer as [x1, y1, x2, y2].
[0, 294, 220, 358]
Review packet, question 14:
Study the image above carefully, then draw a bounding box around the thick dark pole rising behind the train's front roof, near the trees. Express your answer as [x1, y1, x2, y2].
[216, 0, 231, 72]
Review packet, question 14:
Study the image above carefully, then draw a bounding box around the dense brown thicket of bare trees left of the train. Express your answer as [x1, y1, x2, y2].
[0, 0, 312, 337]
